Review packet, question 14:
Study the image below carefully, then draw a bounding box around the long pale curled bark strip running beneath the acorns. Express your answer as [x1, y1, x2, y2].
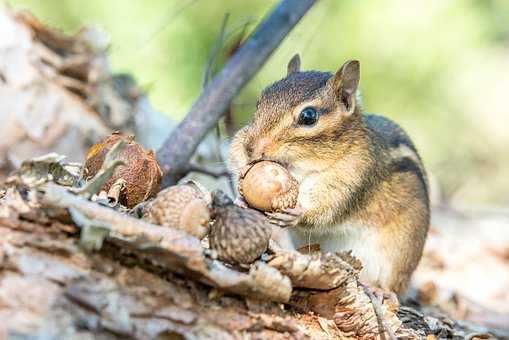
[38, 184, 291, 302]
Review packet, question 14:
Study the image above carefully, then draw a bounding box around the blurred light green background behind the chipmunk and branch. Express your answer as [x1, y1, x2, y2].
[8, 0, 509, 205]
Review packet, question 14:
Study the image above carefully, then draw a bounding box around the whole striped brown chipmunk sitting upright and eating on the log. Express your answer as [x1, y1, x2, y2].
[229, 55, 430, 295]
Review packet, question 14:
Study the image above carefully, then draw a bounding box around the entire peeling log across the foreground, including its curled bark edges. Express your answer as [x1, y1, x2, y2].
[0, 183, 500, 339]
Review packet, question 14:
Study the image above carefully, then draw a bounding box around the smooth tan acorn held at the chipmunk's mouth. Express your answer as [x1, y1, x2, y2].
[239, 161, 299, 211]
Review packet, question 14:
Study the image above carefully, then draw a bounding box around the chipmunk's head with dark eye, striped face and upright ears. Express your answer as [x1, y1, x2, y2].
[232, 55, 361, 177]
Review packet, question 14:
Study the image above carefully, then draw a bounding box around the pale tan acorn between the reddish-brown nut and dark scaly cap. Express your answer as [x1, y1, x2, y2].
[144, 182, 210, 239]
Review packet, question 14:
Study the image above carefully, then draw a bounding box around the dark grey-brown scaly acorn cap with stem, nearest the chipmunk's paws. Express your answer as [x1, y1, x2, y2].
[209, 190, 271, 264]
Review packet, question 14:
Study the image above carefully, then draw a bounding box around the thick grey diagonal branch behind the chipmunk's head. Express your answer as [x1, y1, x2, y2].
[157, 0, 315, 187]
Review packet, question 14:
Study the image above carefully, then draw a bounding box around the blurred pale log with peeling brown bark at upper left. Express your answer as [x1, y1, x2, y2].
[0, 6, 116, 171]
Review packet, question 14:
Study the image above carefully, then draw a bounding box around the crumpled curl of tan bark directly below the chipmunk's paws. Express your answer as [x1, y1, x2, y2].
[268, 250, 410, 339]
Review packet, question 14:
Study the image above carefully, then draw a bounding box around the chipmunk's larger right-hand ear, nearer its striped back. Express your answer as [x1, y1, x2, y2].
[328, 60, 360, 114]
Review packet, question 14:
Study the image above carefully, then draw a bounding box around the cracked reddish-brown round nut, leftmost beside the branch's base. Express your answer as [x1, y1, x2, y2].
[85, 132, 163, 208]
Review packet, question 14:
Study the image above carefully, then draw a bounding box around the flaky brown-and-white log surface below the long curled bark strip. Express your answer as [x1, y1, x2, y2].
[0, 219, 306, 339]
